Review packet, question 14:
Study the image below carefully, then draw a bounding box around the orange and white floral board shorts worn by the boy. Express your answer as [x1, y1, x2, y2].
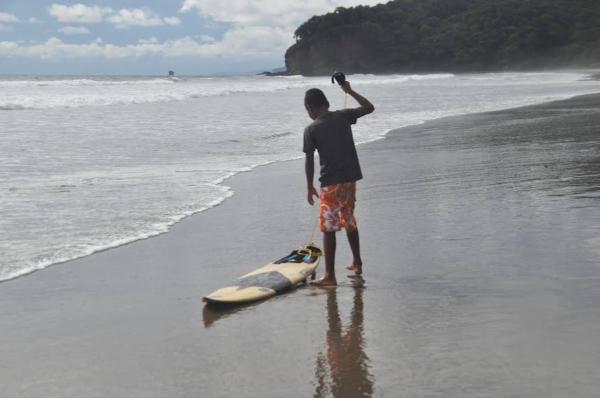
[319, 182, 357, 232]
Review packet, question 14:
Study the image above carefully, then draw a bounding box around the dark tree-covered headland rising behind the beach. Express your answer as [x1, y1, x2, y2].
[285, 0, 600, 75]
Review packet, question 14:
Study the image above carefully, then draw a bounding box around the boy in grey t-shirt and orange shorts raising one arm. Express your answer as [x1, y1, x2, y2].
[303, 82, 375, 286]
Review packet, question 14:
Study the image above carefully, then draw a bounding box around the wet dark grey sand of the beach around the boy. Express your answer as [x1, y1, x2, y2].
[0, 96, 600, 398]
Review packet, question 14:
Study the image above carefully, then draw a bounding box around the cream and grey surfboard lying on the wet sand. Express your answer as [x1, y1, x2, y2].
[203, 245, 321, 304]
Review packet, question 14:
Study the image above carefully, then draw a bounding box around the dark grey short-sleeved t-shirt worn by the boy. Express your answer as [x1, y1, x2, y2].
[303, 109, 362, 187]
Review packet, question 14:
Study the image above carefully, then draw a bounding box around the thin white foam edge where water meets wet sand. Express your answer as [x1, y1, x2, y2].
[0, 90, 600, 286]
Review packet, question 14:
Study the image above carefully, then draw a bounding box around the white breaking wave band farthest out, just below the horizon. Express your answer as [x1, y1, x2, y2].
[0, 74, 454, 111]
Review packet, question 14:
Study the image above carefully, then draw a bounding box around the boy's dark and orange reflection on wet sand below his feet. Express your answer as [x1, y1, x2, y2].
[314, 280, 374, 398]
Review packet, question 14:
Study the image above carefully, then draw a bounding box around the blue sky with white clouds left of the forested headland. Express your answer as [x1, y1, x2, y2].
[0, 0, 382, 75]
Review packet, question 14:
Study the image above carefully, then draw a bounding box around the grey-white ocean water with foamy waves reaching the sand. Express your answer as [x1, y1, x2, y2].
[0, 71, 600, 281]
